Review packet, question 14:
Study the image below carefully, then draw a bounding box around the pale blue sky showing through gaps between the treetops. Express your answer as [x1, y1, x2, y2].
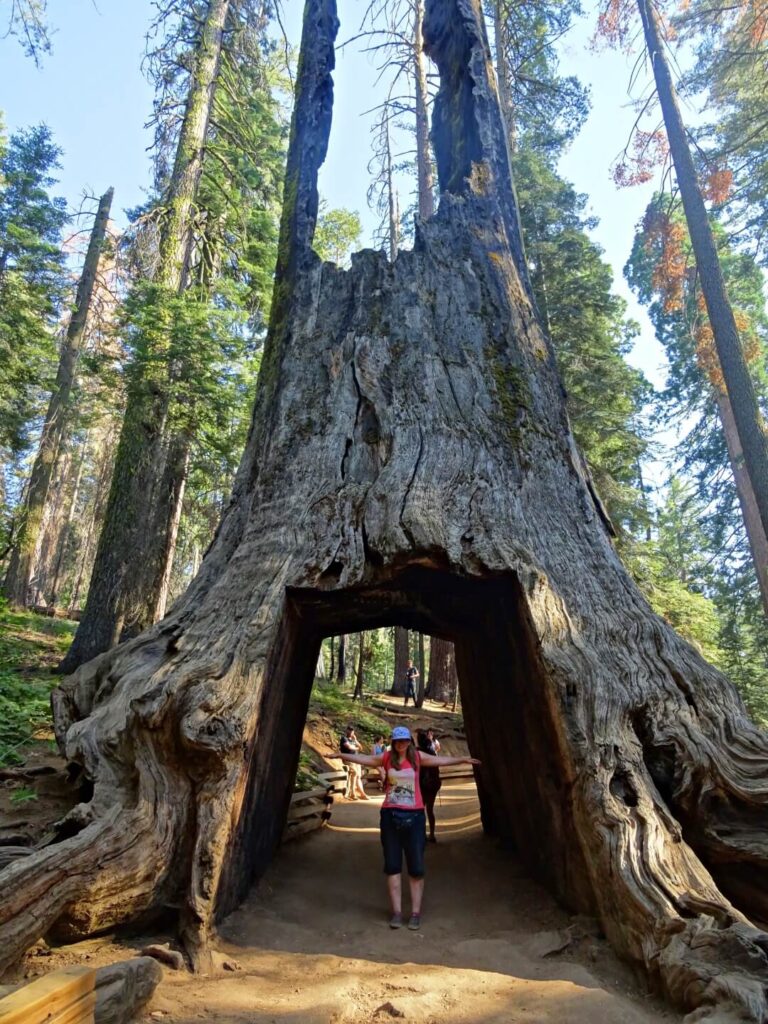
[0, 0, 663, 440]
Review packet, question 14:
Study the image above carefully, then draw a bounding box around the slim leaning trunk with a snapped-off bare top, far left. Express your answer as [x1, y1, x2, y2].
[5, 188, 114, 607]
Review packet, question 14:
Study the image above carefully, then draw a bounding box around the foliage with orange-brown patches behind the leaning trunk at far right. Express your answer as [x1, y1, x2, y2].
[625, 196, 768, 688]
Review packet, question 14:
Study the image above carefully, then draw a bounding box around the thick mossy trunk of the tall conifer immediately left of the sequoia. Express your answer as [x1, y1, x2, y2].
[60, 0, 229, 672]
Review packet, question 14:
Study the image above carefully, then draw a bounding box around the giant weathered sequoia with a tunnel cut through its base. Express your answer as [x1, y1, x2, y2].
[0, 0, 768, 1021]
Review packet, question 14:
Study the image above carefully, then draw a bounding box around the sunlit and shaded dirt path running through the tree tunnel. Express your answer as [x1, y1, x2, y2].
[145, 782, 680, 1024]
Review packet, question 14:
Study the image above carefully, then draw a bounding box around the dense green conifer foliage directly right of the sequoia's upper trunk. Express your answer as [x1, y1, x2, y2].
[513, 142, 651, 530]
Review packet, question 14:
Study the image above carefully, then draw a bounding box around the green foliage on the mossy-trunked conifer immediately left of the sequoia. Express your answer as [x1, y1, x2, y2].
[107, 12, 288, 597]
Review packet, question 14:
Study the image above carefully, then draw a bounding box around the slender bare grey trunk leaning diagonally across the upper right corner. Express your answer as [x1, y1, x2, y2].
[638, 0, 768, 535]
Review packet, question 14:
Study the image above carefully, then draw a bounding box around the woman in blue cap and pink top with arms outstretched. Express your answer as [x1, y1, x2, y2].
[341, 725, 480, 931]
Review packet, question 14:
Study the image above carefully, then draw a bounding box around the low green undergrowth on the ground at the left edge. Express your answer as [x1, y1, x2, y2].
[0, 603, 75, 765]
